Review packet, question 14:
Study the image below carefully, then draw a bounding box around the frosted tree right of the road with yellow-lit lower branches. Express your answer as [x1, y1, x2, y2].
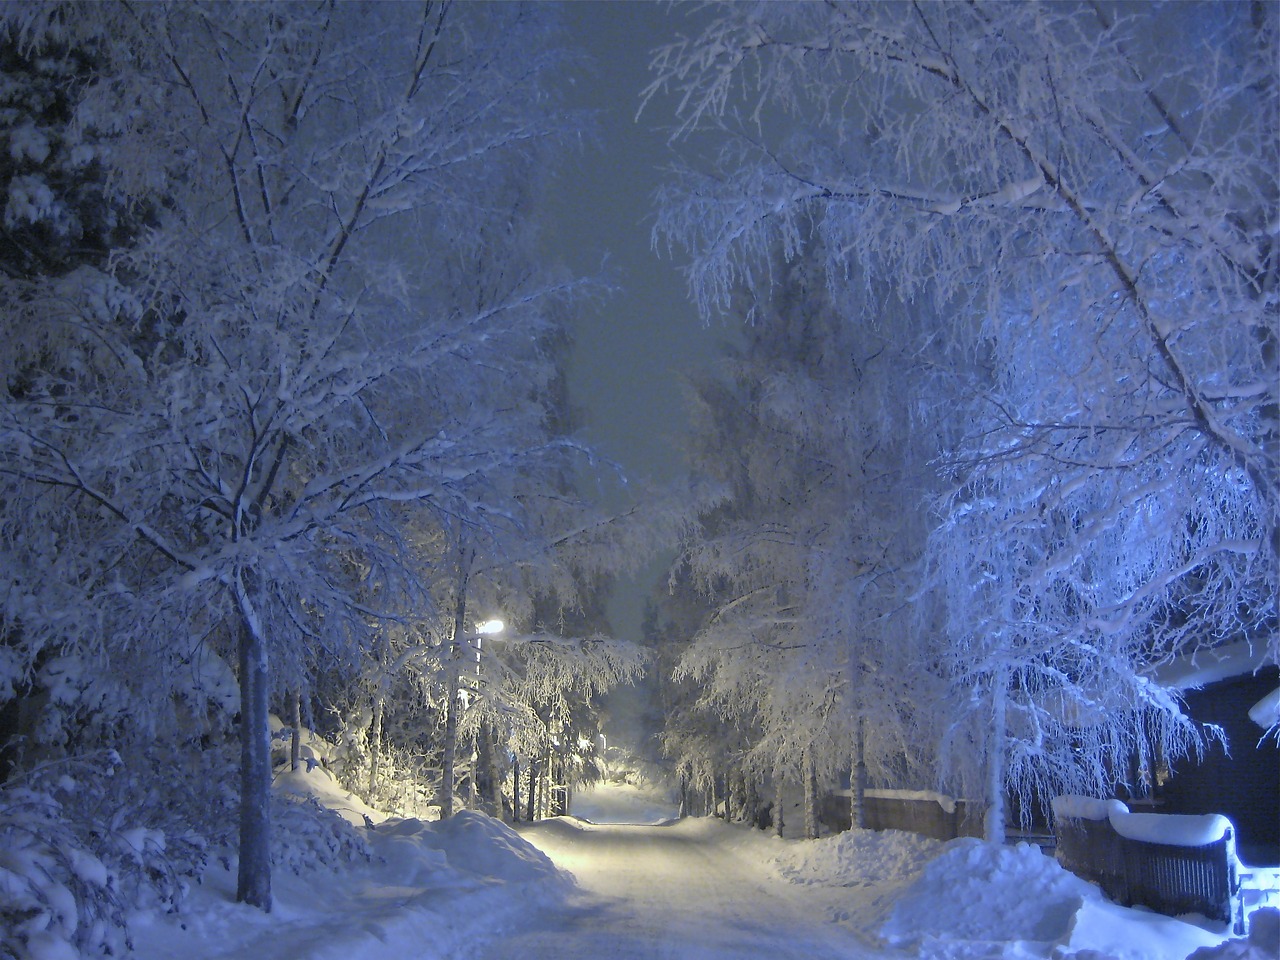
[668, 245, 936, 834]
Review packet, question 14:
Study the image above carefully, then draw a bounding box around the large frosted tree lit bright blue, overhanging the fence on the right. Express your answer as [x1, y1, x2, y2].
[650, 3, 1280, 835]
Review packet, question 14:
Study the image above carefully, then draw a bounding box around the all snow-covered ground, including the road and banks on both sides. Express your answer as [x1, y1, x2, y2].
[117, 783, 1280, 960]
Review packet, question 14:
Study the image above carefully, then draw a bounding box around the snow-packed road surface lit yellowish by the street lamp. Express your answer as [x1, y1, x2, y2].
[480, 819, 892, 960]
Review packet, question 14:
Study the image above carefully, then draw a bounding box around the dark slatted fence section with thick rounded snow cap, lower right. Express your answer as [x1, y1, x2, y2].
[1053, 796, 1244, 933]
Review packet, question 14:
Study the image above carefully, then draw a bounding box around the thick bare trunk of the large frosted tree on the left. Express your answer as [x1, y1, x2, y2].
[236, 591, 271, 913]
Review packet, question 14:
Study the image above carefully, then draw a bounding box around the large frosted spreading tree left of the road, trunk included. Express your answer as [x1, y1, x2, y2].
[0, 3, 586, 908]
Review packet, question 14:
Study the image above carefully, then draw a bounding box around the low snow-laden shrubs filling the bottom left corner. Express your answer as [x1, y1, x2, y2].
[0, 745, 237, 960]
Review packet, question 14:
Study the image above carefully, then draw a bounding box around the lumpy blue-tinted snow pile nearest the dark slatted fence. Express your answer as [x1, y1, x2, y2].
[879, 837, 1102, 952]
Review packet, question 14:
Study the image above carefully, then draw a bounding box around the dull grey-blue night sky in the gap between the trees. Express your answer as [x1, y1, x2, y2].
[535, 0, 732, 650]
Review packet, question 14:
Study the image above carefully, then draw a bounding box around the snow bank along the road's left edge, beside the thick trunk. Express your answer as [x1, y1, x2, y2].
[132, 812, 571, 960]
